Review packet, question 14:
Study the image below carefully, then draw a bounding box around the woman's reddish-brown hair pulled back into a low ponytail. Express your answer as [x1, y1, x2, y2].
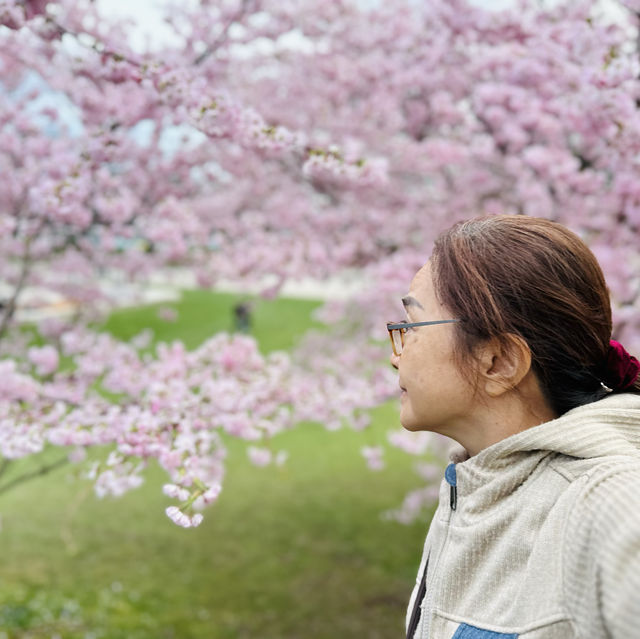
[431, 215, 640, 415]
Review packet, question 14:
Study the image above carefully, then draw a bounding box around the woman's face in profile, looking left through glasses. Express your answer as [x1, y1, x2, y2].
[391, 262, 476, 439]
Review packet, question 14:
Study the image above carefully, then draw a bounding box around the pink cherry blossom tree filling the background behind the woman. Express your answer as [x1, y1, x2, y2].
[0, 0, 640, 526]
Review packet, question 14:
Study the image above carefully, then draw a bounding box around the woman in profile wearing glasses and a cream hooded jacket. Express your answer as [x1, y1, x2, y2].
[388, 216, 640, 639]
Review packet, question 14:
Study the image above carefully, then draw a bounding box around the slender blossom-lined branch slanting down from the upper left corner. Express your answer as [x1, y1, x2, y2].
[0, 0, 387, 188]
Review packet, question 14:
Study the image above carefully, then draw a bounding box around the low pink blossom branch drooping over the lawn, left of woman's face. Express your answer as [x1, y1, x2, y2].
[0, 330, 400, 527]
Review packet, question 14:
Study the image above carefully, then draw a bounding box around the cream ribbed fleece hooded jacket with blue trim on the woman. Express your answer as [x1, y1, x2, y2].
[407, 394, 640, 639]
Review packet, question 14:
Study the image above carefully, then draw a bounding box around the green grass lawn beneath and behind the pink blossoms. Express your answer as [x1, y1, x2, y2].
[0, 291, 436, 639]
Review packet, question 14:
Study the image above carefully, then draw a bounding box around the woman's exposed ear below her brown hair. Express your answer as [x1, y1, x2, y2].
[476, 333, 531, 397]
